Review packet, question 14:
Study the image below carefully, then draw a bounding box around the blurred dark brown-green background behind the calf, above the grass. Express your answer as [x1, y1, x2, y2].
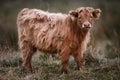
[0, 0, 120, 58]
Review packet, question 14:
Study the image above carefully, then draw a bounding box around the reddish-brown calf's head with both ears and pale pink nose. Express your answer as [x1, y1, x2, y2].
[69, 7, 101, 30]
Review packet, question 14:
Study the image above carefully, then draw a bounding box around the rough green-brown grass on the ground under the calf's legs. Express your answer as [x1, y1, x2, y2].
[0, 50, 120, 80]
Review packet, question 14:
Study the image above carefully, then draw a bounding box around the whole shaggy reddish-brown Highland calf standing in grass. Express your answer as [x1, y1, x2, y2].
[17, 7, 100, 73]
